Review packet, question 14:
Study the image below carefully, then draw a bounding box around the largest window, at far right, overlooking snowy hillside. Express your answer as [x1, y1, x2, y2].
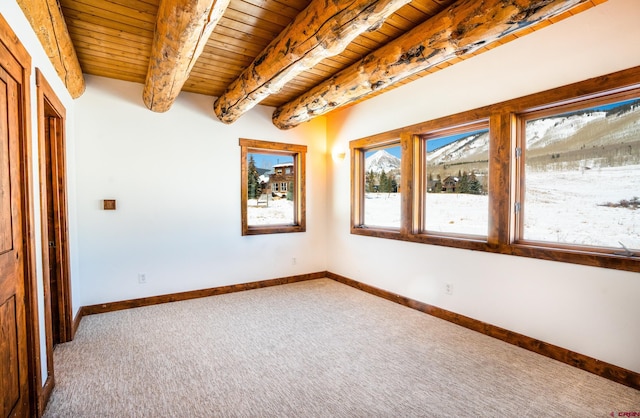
[516, 91, 640, 255]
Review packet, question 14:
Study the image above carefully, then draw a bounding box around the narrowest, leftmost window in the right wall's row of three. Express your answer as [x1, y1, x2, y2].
[353, 139, 402, 230]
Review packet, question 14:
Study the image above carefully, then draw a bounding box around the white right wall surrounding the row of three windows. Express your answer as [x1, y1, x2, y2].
[327, 0, 640, 372]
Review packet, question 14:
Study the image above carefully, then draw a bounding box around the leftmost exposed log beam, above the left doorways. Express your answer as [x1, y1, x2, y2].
[17, 0, 85, 99]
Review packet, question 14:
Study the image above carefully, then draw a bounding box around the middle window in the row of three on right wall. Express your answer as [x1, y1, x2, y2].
[419, 122, 489, 239]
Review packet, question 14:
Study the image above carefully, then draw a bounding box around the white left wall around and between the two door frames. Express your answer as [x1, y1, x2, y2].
[0, 1, 82, 383]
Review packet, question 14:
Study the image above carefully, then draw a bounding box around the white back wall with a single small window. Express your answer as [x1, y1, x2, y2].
[76, 76, 326, 305]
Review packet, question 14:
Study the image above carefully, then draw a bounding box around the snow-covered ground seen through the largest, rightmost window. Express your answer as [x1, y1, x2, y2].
[524, 165, 640, 249]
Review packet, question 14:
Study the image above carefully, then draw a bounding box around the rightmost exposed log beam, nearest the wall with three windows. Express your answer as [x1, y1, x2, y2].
[273, 0, 586, 129]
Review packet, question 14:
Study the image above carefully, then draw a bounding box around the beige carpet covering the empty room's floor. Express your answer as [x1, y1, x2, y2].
[45, 279, 640, 417]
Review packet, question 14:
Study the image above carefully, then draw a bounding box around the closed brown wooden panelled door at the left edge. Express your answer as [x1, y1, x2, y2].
[0, 44, 31, 417]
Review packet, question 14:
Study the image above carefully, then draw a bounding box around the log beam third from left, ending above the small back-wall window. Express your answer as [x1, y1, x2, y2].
[213, 0, 410, 123]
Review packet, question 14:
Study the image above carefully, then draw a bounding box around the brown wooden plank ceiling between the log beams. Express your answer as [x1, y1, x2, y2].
[23, 0, 606, 127]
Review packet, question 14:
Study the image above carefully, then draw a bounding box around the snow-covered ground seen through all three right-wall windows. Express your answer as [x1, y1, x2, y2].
[365, 165, 640, 249]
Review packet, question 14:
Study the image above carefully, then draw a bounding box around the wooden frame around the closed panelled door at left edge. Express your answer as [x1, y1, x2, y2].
[0, 14, 42, 416]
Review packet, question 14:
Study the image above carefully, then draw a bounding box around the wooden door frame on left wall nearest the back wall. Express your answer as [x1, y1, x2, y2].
[36, 68, 74, 412]
